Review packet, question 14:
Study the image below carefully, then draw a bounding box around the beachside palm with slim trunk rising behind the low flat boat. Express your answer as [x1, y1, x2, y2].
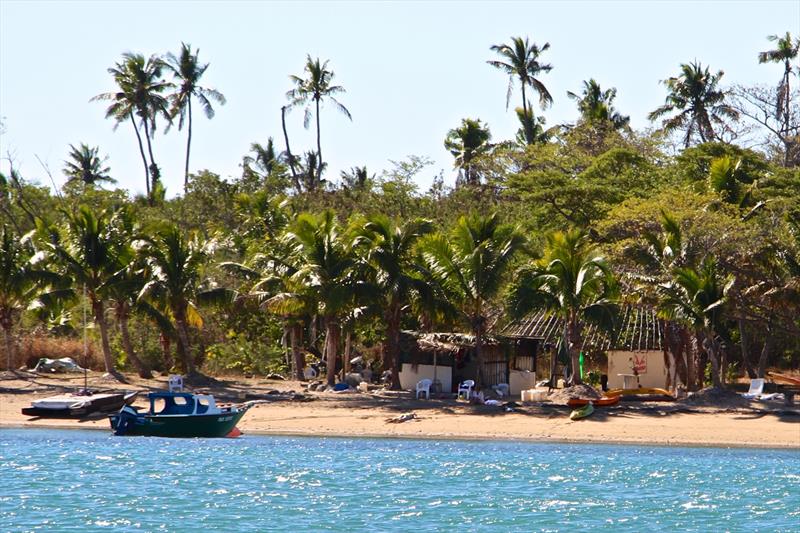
[50, 206, 123, 381]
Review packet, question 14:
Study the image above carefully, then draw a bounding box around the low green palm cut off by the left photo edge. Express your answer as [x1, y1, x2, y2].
[0, 226, 59, 370]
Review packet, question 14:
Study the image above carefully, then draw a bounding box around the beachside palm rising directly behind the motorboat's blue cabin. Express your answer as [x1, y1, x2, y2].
[139, 224, 212, 376]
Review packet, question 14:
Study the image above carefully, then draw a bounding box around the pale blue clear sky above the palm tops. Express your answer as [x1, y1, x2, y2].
[0, 0, 800, 196]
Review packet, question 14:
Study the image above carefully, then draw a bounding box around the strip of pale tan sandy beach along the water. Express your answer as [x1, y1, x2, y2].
[0, 372, 800, 450]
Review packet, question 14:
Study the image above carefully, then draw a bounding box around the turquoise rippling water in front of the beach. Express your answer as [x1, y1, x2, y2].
[0, 430, 800, 532]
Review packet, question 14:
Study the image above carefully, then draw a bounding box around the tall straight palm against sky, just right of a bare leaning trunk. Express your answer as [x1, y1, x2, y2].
[286, 55, 353, 176]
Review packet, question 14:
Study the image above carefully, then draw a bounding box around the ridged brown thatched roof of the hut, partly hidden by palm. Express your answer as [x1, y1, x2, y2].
[502, 305, 663, 352]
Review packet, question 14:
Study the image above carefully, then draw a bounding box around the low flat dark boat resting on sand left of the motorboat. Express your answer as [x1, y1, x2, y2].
[22, 392, 138, 418]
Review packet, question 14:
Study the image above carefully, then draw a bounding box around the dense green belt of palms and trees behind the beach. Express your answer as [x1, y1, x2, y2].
[0, 33, 800, 389]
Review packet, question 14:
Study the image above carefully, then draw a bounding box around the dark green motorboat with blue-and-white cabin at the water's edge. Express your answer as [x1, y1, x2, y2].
[109, 391, 259, 437]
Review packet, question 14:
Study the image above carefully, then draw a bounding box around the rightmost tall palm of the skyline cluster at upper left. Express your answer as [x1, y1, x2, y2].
[164, 43, 225, 190]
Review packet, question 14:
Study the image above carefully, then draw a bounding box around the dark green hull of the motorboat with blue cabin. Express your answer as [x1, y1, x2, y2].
[109, 409, 245, 438]
